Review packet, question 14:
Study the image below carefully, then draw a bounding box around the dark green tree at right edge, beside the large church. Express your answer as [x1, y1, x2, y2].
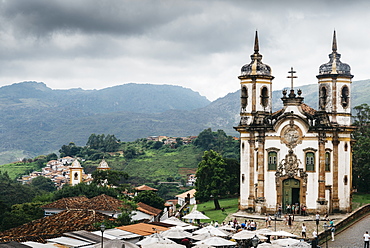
[352, 104, 370, 193]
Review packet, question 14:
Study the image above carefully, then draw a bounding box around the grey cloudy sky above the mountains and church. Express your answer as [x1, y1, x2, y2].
[0, 0, 370, 101]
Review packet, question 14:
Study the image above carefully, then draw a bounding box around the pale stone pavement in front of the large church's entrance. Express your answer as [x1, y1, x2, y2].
[225, 211, 350, 239]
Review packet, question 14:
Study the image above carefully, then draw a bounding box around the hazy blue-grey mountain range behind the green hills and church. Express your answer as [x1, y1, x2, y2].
[0, 80, 370, 164]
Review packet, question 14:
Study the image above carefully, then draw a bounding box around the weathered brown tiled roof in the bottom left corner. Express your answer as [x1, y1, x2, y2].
[0, 210, 109, 242]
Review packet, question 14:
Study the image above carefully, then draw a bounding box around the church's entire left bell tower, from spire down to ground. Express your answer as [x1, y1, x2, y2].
[235, 31, 274, 210]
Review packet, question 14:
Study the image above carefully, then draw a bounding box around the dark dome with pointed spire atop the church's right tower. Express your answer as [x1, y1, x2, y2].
[319, 31, 351, 76]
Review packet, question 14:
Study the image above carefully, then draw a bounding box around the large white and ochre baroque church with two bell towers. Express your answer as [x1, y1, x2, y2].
[234, 31, 355, 214]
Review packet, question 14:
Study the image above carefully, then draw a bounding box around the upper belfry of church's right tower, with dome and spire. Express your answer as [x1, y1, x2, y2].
[316, 31, 353, 126]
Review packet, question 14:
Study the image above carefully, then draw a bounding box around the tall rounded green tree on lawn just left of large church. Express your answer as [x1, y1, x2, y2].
[195, 150, 230, 209]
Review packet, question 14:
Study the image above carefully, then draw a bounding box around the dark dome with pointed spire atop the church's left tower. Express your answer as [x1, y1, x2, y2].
[241, 31, 271, 76]
